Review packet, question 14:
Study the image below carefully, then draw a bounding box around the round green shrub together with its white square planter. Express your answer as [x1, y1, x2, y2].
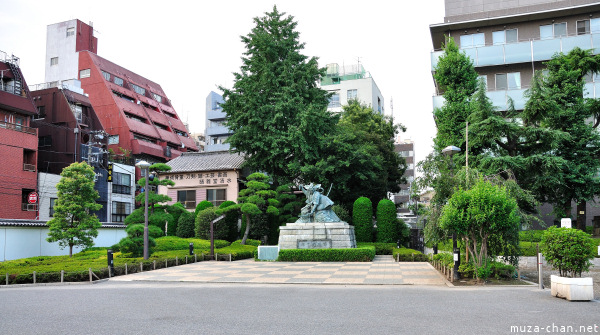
[542, 227, 596, 300]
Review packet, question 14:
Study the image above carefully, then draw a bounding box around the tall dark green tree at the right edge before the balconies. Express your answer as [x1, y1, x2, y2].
[533, 48, 600, 229]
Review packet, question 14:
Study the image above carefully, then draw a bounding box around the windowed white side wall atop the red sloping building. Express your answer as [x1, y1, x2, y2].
[44, 20, 79, 83]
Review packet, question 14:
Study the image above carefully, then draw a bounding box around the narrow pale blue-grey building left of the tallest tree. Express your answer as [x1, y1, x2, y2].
[204, 91, 232, 152]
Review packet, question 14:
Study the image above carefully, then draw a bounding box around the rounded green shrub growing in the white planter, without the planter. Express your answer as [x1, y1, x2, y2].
[542, 227, 596, 277]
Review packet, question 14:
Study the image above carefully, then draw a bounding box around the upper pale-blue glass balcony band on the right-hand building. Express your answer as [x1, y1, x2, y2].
[431, 33, 600, 71]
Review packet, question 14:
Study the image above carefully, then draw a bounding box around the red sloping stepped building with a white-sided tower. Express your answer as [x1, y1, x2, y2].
[46, 20, 198, 167]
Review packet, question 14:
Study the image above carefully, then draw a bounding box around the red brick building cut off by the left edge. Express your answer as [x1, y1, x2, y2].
[0, 51, 38, 219]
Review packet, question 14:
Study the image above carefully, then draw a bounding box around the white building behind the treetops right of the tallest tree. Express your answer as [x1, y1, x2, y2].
[321, 64, 384, 114]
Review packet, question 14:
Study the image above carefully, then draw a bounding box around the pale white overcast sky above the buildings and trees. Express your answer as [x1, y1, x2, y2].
[0, 0, 444, 167]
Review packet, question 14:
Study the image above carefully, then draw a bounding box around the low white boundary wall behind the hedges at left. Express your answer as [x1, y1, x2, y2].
[0, 226, 127, 261]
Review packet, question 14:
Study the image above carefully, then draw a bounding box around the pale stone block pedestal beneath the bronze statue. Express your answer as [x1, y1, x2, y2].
[279, 221, 356, 249]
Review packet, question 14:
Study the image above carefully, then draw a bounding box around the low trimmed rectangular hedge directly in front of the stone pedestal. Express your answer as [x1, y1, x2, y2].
[277, 246, 375, 262]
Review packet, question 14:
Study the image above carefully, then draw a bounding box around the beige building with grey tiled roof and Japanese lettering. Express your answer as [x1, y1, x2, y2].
[158, 151, 244, 211]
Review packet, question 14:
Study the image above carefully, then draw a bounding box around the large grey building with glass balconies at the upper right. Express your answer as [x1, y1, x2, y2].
[430, 0, 600, 226]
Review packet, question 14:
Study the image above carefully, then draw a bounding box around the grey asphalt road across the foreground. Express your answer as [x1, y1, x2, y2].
[0, 282, 600, 334]
